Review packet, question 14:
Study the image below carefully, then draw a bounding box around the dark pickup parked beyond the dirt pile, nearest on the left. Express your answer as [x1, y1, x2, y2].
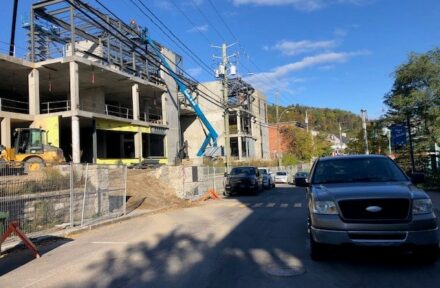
[225, 167, 263, 196]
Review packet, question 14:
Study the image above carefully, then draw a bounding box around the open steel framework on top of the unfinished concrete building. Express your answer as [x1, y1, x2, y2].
[22, 0, 174, 83]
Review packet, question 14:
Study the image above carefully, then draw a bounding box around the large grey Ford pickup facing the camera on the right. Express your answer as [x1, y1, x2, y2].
[304, 155, 439, 261]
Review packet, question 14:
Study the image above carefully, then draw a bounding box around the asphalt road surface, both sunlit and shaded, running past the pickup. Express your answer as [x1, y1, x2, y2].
[0, 185, 440, 288]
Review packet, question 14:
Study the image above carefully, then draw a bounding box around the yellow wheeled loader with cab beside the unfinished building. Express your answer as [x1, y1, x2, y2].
[0, 128, 65, 174]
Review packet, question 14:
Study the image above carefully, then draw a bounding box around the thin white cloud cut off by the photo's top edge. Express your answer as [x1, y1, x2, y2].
[232, 0, 374, 11]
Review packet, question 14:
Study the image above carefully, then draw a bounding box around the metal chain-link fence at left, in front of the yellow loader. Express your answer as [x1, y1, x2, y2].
[0, 164, 127, 246]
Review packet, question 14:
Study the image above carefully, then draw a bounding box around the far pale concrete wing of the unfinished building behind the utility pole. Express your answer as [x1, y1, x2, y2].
[182, 78, 270, 160]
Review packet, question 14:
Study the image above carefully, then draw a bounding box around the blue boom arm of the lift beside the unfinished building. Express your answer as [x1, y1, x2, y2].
[147, 37, 218, 157]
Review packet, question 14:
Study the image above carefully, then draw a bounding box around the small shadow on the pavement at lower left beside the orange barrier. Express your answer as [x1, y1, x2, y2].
[0, 236, 73, 276]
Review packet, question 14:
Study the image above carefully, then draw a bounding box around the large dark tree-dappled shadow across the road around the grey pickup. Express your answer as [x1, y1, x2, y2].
[56, 188, 440, 288]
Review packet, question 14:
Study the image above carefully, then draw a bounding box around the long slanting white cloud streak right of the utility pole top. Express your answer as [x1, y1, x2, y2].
[245, 50, 371, 91]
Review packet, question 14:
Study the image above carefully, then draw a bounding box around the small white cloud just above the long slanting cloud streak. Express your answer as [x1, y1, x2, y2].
[263, 40, 336, 56]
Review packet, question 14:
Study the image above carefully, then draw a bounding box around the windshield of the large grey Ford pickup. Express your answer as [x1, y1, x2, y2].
[312, 158, 408, 184]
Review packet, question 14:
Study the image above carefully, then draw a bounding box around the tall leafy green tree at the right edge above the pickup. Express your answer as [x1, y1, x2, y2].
[385, 48, 440, 172]
